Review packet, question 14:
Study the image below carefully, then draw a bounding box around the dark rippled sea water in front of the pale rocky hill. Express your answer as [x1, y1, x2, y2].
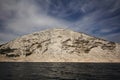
[0, 62, 120, 80]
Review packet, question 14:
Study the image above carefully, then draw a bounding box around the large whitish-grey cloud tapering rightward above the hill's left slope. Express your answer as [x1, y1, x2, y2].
[6, 0, 70, 33]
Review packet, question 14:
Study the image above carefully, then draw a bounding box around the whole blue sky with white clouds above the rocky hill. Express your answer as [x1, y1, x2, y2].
[0, 0, 120, 44]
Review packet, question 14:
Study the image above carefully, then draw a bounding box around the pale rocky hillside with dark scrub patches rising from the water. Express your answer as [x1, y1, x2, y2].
[0, 29, 120, 62]
